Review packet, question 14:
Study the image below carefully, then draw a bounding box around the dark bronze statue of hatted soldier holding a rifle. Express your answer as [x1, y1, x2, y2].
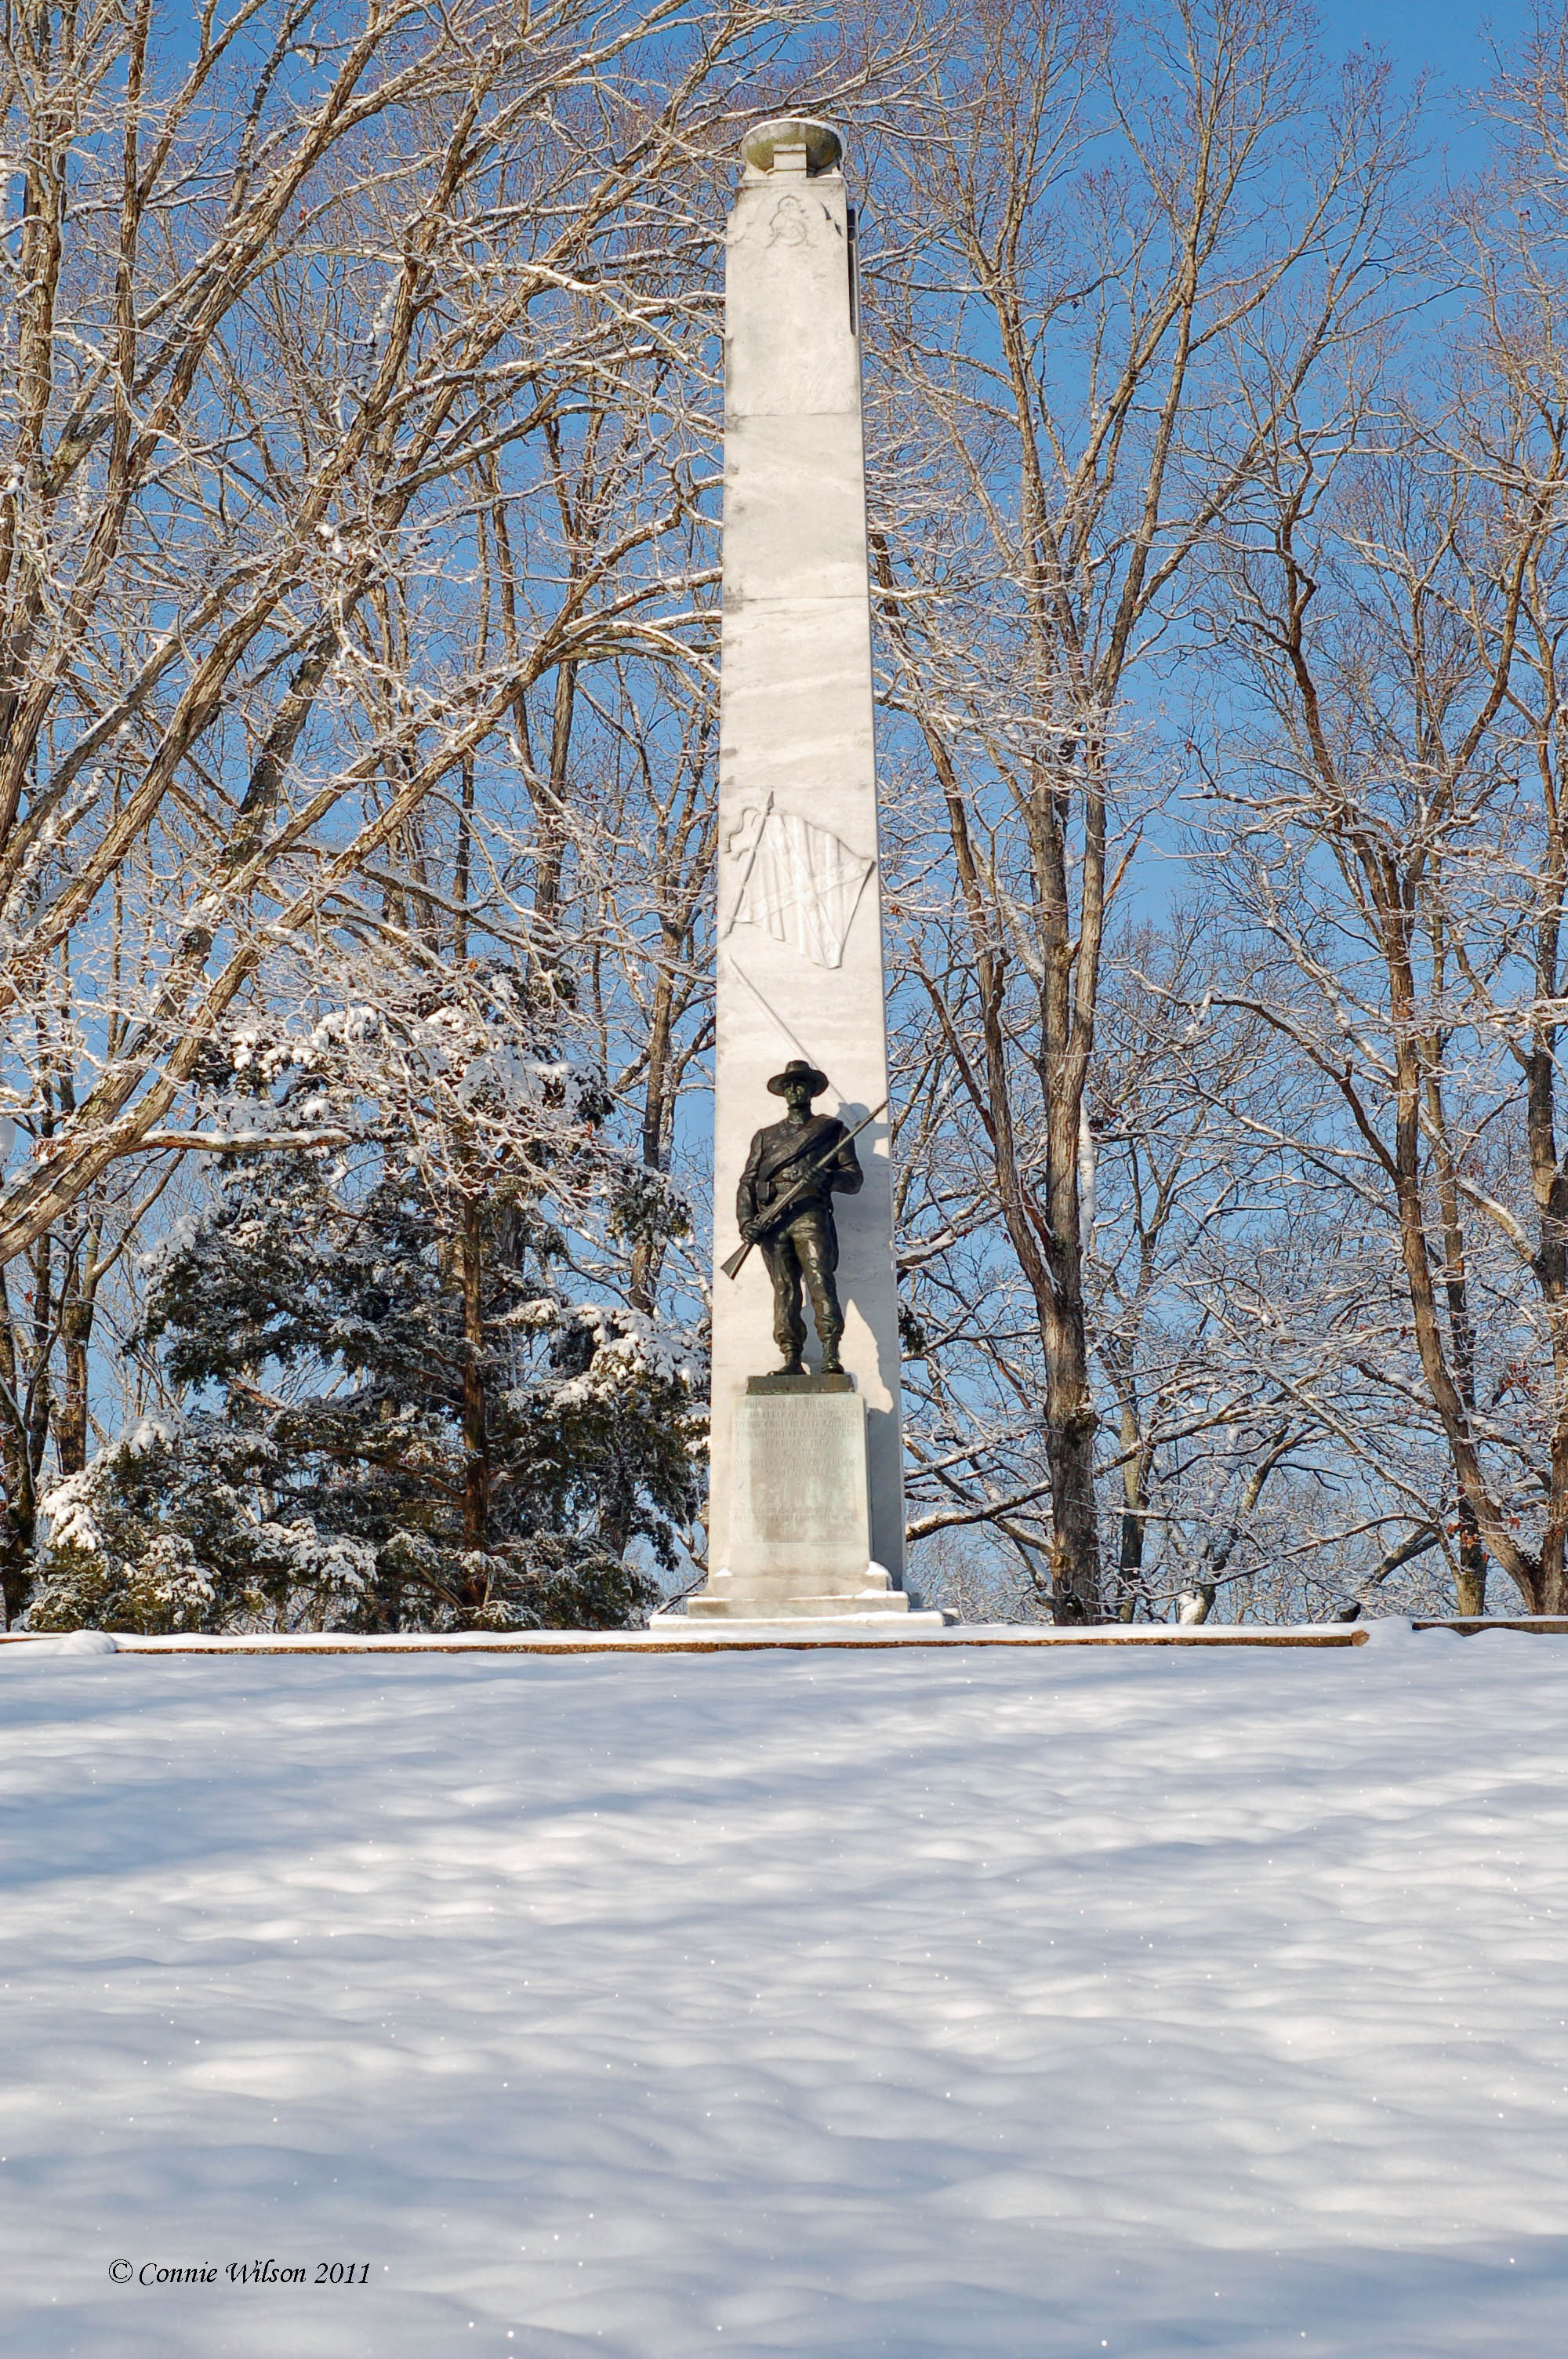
[735, 1057, 866, 1376]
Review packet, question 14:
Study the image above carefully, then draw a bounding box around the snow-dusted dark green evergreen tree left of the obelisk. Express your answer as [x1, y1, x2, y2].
[28, 969, 700, 1630]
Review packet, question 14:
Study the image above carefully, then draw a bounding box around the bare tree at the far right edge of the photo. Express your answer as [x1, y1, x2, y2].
[1217, 31, 1568, 1613]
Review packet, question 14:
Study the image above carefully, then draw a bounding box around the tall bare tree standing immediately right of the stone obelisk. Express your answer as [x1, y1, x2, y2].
[868, 0, 1400, 1620]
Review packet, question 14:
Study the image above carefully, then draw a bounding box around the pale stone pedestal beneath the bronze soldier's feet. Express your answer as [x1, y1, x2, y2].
[686, 1376, 941, 1623]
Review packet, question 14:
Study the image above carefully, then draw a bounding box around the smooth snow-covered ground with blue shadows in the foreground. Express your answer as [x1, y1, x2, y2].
[0, 1630, 1568, 2359]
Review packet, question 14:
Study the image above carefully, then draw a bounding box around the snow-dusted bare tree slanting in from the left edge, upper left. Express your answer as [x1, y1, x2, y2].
[0, 0, 829, 1255]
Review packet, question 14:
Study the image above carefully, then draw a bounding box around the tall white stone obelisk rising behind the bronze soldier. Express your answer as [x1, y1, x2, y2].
[693, 118, 906, 1616]
